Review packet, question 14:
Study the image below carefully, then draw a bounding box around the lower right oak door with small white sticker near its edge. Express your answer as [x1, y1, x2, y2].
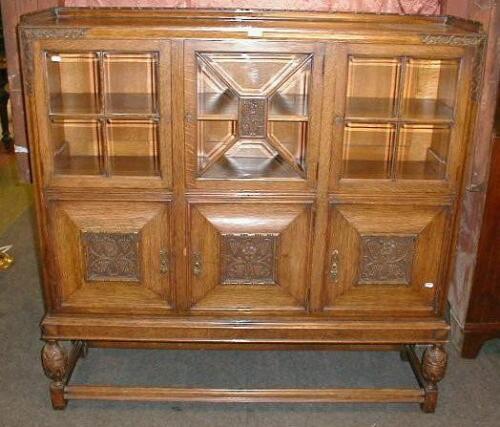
[324, 204, 448, 316]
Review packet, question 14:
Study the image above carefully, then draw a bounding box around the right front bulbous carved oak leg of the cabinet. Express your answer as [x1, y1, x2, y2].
[422, 344, 448, 412]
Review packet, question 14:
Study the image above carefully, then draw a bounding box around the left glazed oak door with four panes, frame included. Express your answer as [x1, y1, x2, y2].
[34, 40, 172, 188]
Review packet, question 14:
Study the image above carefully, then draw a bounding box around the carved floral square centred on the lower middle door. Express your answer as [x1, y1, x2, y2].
[220, 234, 278, 285]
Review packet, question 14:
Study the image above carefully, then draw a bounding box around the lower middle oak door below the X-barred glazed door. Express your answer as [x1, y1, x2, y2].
[189, 203, 311, 314]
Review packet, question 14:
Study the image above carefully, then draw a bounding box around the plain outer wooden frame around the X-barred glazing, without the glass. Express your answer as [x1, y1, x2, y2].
[184, 40, 324, 191]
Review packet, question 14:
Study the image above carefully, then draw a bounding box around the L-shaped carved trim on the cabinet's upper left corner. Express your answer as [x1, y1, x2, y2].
[21, 28, 87, 94]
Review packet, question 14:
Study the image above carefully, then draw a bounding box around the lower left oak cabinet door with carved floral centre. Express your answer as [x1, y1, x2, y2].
[50, 201, 173, 314]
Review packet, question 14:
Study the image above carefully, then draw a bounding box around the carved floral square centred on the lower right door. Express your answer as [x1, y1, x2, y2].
[358, 235, 416, 284]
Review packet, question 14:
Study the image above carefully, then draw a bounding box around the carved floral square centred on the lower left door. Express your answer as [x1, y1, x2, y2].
[82, 231, 140, 282]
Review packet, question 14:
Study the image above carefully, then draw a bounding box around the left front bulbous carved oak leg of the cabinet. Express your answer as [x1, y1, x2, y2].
[42, 341, 69, 409]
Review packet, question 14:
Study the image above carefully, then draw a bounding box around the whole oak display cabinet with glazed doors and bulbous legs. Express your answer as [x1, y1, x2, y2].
[19, 8, 485, 412]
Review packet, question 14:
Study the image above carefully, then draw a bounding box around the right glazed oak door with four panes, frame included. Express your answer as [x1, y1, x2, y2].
[330, 45, 472, 192]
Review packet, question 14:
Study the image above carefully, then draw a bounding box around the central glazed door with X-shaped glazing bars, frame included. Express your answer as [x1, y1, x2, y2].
[185, 41, 323, 190]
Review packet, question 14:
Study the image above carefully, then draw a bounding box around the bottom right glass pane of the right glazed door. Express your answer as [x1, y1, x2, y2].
[397, 125, 450, 179]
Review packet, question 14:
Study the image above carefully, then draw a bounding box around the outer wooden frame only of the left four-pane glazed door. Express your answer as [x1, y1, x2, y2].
[33, 39, 173, 189]
